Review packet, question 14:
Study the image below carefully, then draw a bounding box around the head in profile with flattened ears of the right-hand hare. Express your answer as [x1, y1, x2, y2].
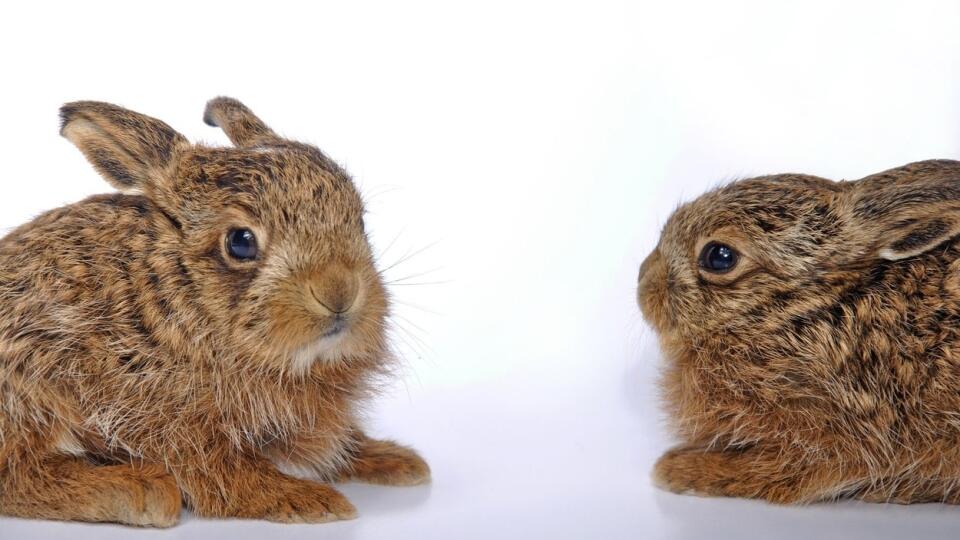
[638, 161, 960, 344]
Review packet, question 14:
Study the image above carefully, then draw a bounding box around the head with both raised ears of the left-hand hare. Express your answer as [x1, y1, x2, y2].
[61, 98, 387, 371]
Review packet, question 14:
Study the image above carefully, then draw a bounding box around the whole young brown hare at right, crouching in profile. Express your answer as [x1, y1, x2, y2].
[638, 160, 960, 503]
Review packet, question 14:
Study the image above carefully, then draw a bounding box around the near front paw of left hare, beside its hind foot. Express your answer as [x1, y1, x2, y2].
[262, 480, 357, 523]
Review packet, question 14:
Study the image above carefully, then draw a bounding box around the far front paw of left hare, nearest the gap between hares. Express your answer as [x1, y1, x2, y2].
[343, 438, 430, 486]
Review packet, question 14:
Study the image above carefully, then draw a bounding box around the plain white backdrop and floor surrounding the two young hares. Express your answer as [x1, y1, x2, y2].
[0, 0, 960, 539]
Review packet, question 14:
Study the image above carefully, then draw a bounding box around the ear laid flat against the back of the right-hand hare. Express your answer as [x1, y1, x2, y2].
[854, 160, 960, 261]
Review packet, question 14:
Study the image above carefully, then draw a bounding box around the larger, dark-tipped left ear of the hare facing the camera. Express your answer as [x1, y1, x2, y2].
[60, 101, 189, 192]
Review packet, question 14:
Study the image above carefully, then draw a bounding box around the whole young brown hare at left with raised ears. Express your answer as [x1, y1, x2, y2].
[0, 98, 429, 527]
